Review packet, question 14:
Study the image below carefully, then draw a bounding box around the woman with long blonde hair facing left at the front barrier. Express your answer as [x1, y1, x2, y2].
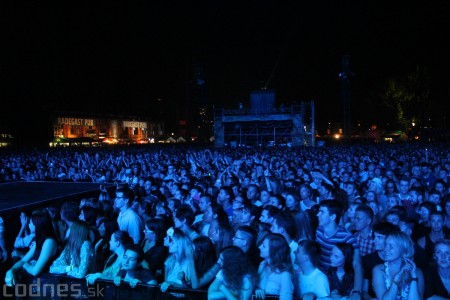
[161, 227, 198, 292]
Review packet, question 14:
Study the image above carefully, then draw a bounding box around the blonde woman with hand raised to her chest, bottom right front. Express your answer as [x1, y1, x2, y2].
[372, 232, 424, 300]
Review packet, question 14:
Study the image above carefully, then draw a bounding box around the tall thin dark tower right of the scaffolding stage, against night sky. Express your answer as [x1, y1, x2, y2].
[339, 55, 353, 140]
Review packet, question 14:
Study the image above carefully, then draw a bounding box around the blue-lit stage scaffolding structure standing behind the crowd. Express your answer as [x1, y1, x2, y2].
[214, 101, 315, 147]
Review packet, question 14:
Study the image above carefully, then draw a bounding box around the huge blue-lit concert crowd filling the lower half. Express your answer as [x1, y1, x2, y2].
[0, 143, 450, 300]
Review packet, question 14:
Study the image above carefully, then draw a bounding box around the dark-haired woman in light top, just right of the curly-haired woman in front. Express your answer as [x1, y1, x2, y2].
[255, 233, 294, 300]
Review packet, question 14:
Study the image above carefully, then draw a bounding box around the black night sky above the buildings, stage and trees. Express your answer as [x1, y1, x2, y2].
[0, 0, 450, 138]
